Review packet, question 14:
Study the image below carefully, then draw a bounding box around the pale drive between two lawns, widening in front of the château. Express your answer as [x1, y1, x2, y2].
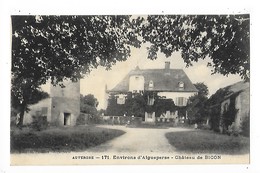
[87, 126, 191, 153]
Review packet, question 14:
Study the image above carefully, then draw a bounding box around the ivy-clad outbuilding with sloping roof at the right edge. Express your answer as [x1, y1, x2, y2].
[208, 81, 250, 133]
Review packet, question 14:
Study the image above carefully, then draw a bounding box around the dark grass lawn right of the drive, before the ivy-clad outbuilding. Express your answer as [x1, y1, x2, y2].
[166, 130, 250, 155]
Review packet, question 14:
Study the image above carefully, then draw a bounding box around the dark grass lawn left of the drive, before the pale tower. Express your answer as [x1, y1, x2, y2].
[11, 126, 125, 153]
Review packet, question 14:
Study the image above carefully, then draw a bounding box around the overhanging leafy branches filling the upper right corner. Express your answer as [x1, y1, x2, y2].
[139, 14, 250, 80]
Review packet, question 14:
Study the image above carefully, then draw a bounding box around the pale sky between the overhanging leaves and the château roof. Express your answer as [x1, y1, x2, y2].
[80, 45, 241, 109]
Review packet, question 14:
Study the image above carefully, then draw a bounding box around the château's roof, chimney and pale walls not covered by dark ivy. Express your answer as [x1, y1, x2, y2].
[107, 62, 197, 123]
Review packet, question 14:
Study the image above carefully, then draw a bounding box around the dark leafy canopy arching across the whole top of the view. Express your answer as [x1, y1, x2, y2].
[11, 15, 250, 125]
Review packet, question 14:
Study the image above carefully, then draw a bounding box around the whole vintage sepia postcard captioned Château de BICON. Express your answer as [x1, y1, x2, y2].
[10, 14, 250, 166]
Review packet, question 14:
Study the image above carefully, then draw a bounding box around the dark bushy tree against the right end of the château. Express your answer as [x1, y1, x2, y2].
[187, 82, 208, 123]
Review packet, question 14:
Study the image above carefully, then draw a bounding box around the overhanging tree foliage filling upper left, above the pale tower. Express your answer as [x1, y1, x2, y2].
[11, 16, 140, 124]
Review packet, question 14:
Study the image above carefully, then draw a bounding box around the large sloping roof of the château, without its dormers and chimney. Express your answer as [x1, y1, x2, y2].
[110, 67, 197, 92]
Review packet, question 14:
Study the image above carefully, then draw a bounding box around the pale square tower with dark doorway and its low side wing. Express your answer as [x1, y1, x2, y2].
[23, 81, 80, 126]
